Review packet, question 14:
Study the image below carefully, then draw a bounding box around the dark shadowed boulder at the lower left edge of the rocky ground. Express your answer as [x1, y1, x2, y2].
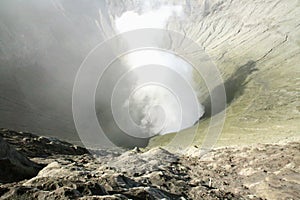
[0, 137, 42, 183]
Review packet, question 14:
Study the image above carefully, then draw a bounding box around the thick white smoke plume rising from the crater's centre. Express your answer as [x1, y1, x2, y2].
[97, 4, 204, 138]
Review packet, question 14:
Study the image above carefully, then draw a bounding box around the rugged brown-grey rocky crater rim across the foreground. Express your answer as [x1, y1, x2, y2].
[0, 129, 300, 200]
